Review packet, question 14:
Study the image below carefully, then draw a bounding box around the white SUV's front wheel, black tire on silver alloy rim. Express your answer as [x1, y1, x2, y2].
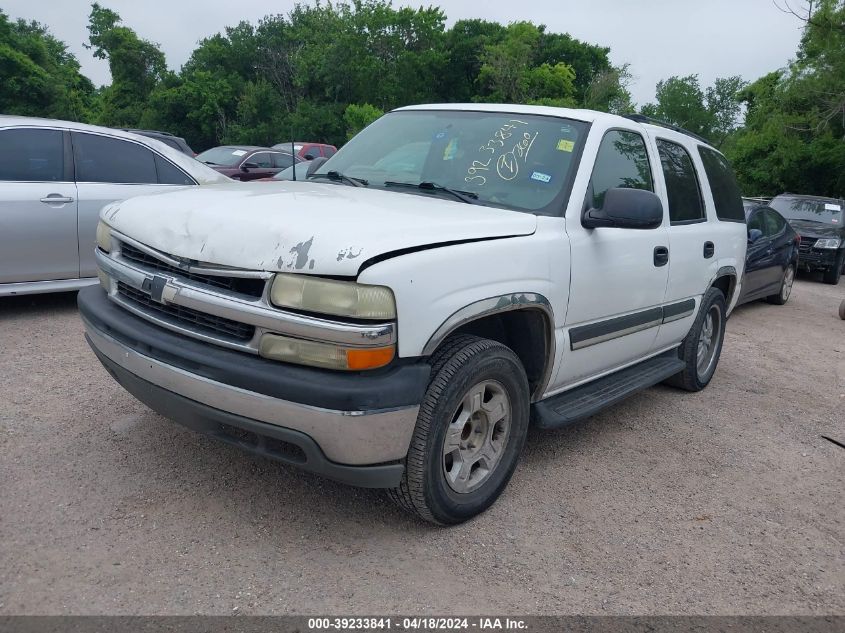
[388, 335, 530, 525]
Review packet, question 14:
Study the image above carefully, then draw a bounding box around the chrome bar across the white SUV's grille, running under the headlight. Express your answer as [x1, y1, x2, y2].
[96, 249, 396, 347]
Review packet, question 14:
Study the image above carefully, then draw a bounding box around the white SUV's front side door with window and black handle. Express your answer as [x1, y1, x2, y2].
[555, 129, 669, 388]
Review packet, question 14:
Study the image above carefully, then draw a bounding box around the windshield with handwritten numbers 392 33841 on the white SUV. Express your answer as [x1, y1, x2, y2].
[315, 110, 587, 215]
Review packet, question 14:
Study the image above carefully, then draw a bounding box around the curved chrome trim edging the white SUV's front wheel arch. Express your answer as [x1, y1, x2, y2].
[422, 292, 555, 401]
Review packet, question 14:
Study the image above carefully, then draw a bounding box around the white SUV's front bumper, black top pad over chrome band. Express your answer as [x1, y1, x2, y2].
[78, 287, 430, 487]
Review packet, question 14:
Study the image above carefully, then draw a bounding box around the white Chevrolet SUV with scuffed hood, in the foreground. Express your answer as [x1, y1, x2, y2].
[79, 104, 747, 524]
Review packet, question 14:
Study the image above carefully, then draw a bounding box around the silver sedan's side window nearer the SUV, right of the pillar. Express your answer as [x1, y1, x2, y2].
[73, 132, 158, 184]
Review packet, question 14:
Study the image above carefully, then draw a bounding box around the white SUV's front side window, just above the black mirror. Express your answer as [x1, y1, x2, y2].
[588, 130, 654, 209]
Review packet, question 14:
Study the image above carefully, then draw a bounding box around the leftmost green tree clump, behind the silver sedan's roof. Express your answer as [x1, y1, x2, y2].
[0, 11, 94, 121]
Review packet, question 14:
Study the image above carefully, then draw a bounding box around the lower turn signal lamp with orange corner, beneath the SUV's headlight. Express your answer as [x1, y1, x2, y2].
[258, 334, 395, 370]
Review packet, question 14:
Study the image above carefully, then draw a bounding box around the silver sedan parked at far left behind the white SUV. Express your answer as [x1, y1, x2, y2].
[0, 115, 231, 296]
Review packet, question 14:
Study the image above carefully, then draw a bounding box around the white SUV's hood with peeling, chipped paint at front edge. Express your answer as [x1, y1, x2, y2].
[101, 181, 537, 276]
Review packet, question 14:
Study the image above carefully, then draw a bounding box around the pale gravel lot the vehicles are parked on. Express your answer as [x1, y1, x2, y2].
[0, 278, 845, 614]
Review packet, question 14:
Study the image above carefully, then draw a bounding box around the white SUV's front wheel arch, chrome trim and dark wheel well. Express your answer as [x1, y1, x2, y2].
[423, 293, 555, 402]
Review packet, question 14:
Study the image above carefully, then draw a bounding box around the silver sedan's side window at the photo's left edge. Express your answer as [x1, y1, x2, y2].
[0, 128, 64, 182]
